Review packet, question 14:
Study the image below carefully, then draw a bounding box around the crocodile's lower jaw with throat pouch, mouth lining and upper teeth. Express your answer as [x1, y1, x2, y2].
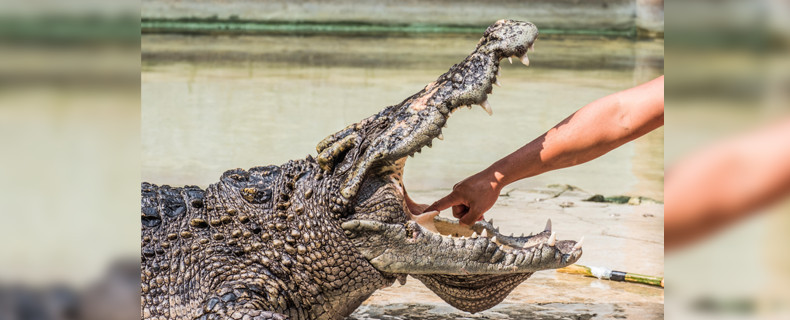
[342, 44, 583, 313]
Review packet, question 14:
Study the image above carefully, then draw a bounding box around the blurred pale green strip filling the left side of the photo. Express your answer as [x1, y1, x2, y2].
[0, 0, 140, 319]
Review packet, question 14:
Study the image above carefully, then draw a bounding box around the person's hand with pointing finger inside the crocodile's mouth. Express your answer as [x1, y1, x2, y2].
[424, 171, 501, 225]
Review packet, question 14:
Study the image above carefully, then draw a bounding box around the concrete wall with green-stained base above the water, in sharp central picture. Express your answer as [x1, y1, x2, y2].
[141, 0, 664, 32]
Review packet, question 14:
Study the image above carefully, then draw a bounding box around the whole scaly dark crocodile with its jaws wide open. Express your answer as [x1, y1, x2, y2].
[141, 20, 582, 319]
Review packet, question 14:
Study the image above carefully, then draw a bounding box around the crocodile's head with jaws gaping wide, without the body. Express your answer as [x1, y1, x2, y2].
[317, 20, 582, 312]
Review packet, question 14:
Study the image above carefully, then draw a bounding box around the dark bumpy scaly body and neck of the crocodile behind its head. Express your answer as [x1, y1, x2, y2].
[142, 164, 395, 319]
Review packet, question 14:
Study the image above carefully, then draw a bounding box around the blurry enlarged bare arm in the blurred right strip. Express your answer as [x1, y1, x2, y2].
[664, 119, 790, 250]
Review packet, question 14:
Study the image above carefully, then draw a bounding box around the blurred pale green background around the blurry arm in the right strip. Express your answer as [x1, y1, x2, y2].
[664, 0, 790, 319]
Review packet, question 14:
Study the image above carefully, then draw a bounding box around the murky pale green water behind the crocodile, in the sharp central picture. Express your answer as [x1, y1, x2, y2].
[142, 35, 664, 199]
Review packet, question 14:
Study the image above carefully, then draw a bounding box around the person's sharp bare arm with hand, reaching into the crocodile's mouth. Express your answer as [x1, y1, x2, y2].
[425, 76, 664, 225]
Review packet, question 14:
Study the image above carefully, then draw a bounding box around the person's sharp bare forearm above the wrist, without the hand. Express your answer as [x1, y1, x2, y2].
[481, 77, 664, 189]
